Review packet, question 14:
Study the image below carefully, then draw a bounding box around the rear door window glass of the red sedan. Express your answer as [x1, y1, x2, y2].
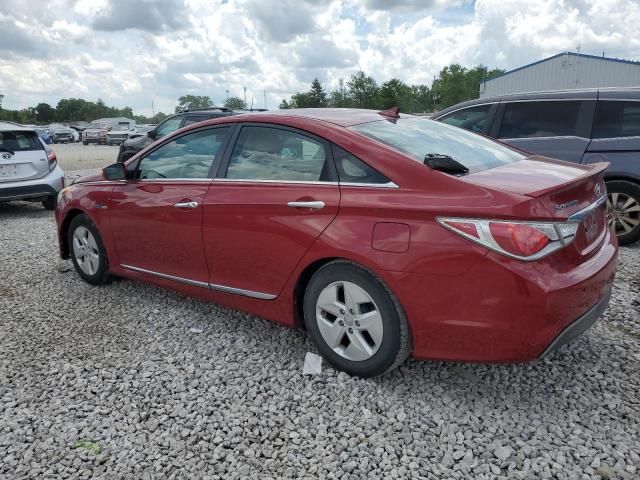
[227, 127, 328, 182]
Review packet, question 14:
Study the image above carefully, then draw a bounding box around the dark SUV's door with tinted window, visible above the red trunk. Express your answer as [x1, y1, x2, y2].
[496, 99, 595, 163]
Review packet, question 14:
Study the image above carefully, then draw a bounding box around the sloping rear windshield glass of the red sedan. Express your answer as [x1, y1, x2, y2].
[349, 118, 525, 172]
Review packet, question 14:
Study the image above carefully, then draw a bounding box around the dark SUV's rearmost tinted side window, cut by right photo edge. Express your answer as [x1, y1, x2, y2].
[592, 100, 640, 138]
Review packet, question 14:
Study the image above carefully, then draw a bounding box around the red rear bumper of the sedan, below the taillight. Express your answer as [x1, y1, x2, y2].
[383, 227, 617, 363]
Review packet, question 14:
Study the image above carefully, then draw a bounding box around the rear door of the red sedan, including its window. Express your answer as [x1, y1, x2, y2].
[203, 124, 340, 299]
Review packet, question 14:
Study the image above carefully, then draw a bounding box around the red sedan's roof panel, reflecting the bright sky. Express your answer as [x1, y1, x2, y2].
[220, 108, 413, 127]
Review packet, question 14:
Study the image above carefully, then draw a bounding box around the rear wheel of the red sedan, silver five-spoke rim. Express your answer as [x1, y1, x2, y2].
[304, 260, 411, 377]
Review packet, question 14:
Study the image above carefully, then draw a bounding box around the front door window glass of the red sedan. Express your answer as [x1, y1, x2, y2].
[136, 127, 229, 180]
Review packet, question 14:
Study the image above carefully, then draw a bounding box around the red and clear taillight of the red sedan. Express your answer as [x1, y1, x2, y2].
[436, 217, 579, 260]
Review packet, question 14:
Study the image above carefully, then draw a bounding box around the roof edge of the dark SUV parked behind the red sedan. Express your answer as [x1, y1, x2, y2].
[432, 87, 640, 118]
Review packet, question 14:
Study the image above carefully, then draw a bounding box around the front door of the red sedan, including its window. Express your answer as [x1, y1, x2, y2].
[109, 126, 231, 286]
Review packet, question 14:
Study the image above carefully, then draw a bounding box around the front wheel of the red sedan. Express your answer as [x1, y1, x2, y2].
[67, 214, 110, 285]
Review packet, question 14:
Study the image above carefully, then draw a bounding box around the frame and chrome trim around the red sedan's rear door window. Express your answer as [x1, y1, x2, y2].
[214, 122, 339, 185]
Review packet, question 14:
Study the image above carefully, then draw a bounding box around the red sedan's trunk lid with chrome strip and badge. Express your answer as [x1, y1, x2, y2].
[460, 157, 609, 256]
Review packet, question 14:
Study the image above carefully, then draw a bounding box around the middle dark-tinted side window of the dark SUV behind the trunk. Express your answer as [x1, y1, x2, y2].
[498, 101, 582, 138]
